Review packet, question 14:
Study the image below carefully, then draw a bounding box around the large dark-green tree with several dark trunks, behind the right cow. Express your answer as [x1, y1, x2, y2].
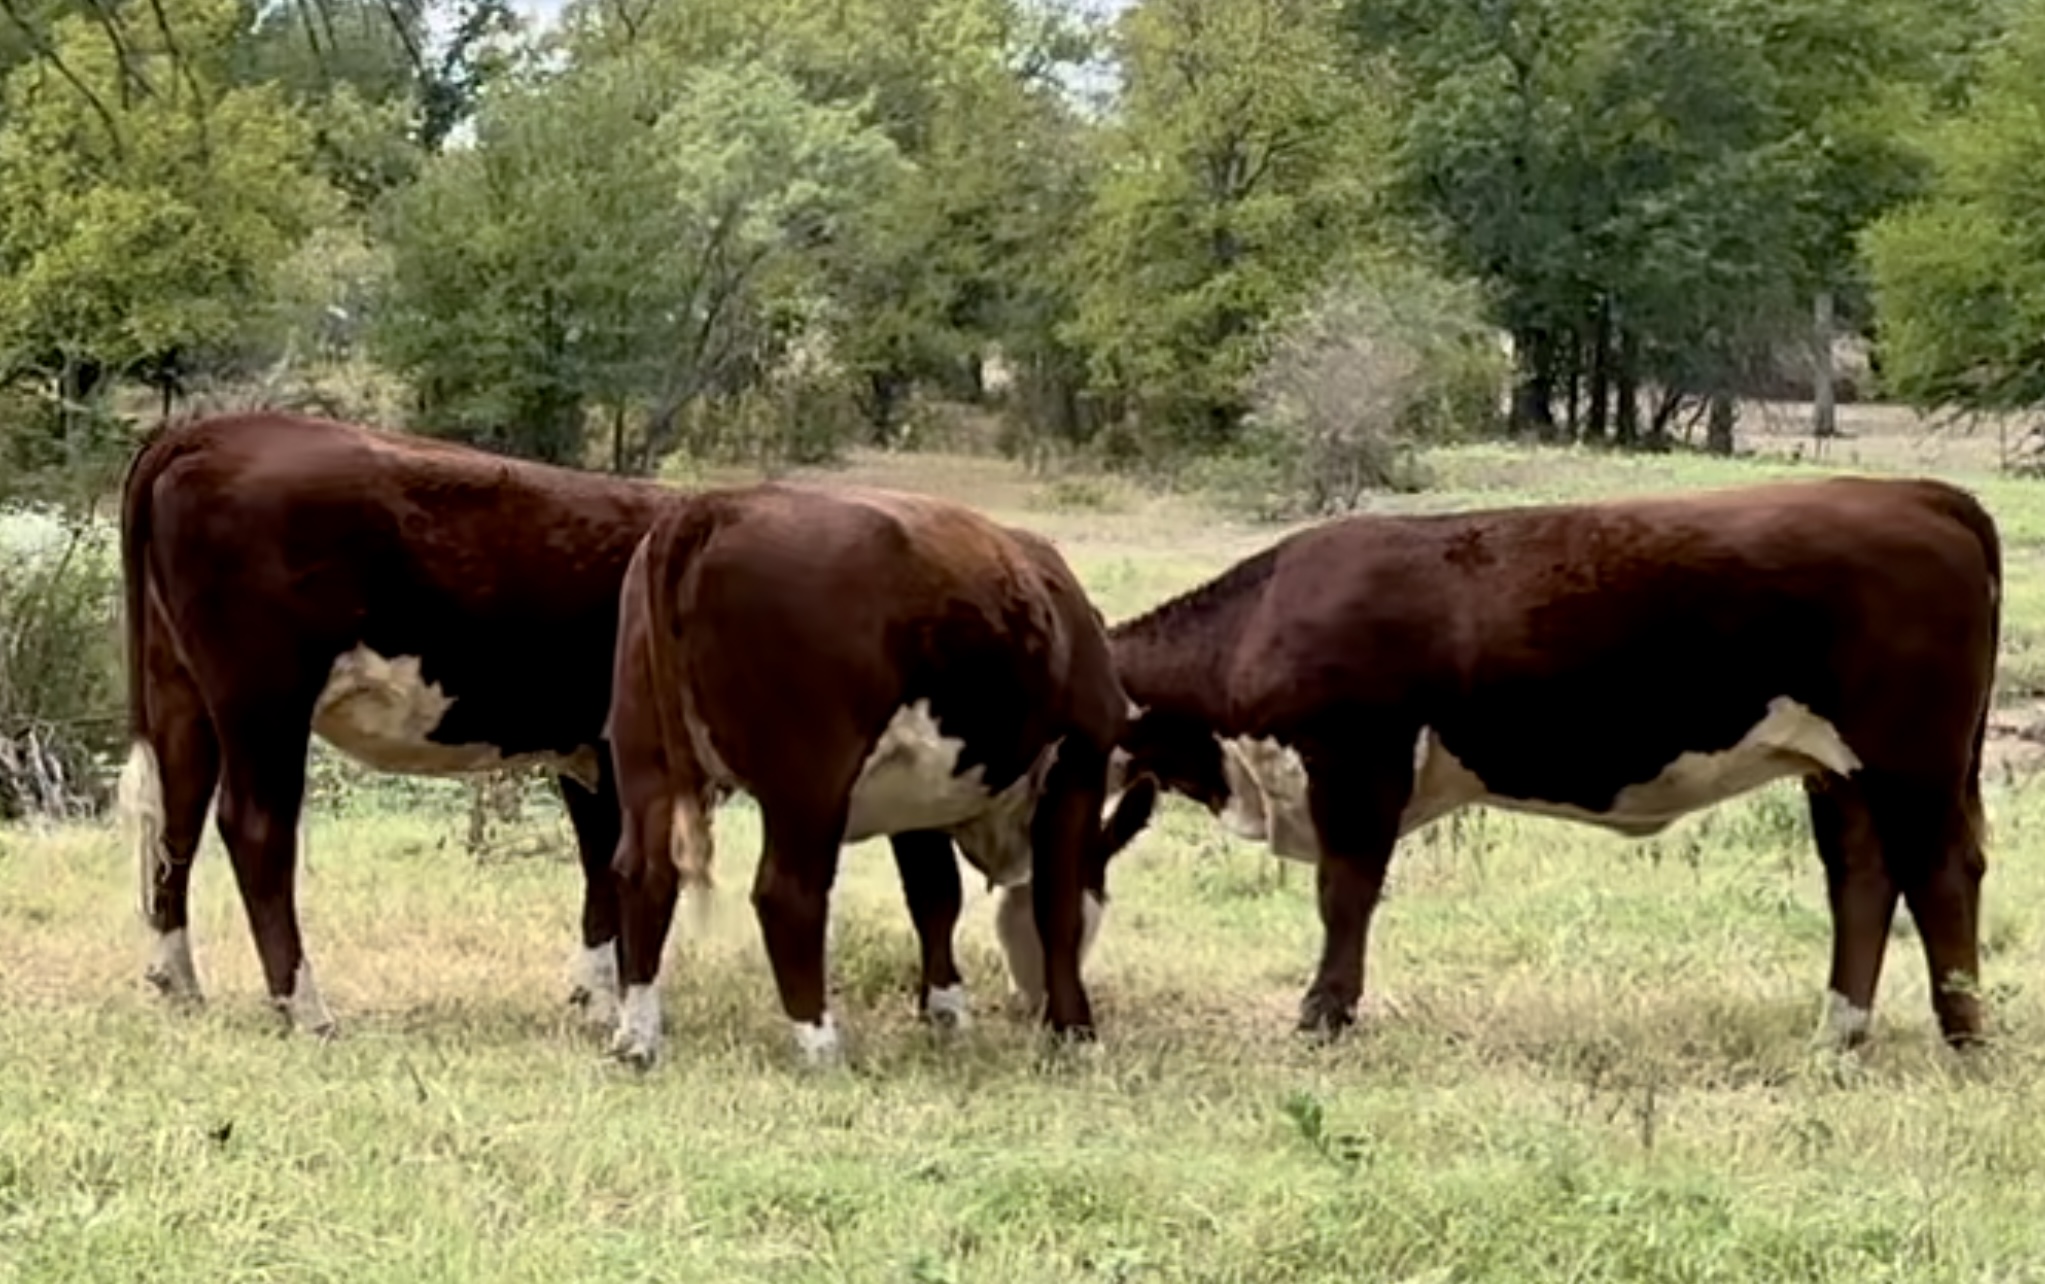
[1352, 0, 1978, 448]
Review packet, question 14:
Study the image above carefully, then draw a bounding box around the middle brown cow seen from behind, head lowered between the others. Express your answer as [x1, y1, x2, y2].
[607, 485, 1155, 1065]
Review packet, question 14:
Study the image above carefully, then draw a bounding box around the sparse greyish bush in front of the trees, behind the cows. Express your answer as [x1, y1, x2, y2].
[1205, 266, 1507, 519]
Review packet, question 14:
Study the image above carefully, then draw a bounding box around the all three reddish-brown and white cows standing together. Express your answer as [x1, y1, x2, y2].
[107, 413, 2002, 1065]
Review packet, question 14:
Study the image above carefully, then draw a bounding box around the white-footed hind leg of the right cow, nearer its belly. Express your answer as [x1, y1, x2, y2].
[1804, 777, 1898, 1051]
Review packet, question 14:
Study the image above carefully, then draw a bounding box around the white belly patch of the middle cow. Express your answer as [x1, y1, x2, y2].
[845, 699, 1053, 885]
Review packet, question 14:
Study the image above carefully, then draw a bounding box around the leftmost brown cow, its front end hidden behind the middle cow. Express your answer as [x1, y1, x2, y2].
[121, 413, 673, 1033]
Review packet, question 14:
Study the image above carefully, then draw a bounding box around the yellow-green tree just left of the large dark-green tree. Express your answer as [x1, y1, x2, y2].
[1065, 0, 1389, 448]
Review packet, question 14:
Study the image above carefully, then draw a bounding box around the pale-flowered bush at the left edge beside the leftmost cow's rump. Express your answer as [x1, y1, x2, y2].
[0, 507, 125, 820]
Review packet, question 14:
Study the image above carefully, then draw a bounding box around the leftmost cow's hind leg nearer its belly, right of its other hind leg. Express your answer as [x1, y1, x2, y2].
[219, 715, 335, 1037]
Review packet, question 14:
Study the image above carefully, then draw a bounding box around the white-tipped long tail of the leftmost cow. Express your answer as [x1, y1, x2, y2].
[115, 423, 170, 922]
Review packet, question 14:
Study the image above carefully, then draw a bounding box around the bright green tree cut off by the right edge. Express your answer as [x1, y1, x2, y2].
[1865, 4, 2045, 411]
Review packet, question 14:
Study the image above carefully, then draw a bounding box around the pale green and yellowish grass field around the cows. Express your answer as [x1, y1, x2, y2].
[0, 419, 2045, 1284]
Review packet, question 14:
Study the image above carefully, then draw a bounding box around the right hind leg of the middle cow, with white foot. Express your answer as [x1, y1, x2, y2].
[753, 799, 845, 1065]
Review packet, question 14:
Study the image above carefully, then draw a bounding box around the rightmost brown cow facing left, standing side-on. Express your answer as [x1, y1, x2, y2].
[1110, 478, 2002, 1047]
